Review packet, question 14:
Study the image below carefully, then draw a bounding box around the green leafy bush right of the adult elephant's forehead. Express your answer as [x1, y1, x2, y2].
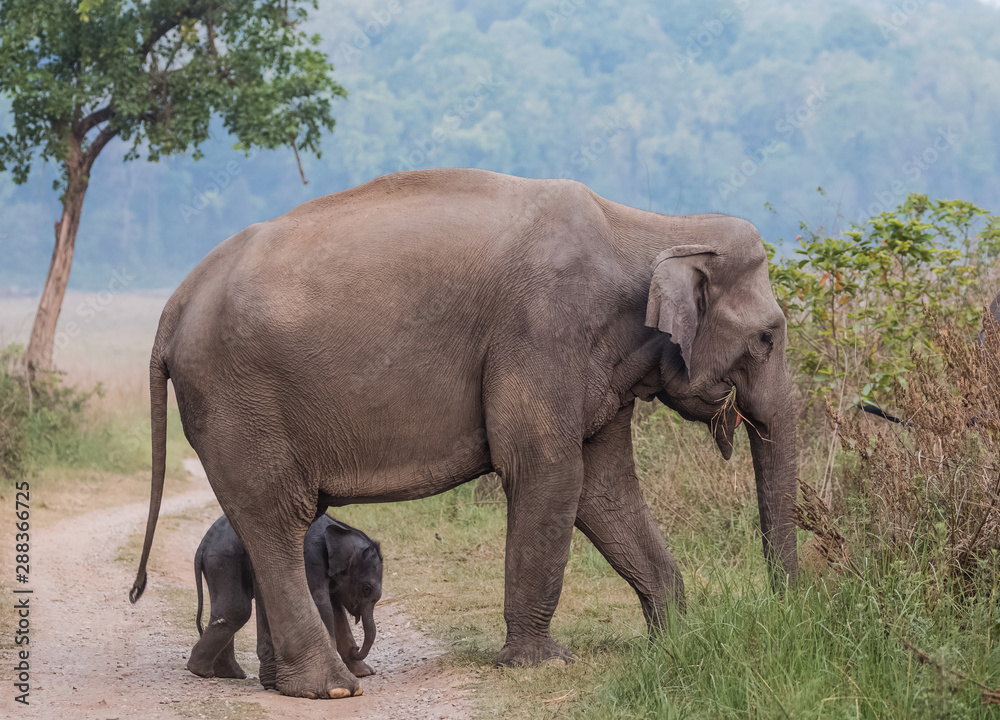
[771, 194, 1000, 402]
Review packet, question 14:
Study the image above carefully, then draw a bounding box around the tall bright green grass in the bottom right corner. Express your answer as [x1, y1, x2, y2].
[575, 564, 1000, 718]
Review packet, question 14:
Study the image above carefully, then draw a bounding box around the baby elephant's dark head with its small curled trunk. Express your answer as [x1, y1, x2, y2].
[326, 521, 382, 660]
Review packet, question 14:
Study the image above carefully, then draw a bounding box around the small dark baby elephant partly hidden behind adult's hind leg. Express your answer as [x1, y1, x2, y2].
[188, 515, 382, 687]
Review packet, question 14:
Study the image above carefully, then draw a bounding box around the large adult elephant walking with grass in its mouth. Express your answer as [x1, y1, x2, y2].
[132, 170, 797, 697]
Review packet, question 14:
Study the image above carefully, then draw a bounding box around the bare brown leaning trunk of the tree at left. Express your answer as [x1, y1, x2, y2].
[24, 147, 92, 381]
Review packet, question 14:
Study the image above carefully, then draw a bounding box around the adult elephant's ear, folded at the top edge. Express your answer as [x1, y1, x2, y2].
[646, 245, 718, 378]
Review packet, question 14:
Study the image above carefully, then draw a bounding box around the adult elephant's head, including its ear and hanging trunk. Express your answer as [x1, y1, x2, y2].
[646, 216, 798, 584]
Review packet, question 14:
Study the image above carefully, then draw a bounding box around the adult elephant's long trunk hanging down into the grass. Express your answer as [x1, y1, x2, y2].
[747, 374, 798, 589]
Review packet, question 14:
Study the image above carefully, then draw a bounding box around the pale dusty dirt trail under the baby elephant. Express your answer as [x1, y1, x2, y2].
[0, 461, 472, 720]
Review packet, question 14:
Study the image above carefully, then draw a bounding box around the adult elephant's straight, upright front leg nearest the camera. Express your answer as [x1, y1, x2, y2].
[497, 448, 583, 665]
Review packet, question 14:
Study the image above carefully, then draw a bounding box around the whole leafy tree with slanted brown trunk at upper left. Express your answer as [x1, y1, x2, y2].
[0, 0, 346, 378]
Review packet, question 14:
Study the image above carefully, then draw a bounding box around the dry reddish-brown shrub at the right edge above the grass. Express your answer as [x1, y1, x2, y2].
[840, 313, 1000, 590]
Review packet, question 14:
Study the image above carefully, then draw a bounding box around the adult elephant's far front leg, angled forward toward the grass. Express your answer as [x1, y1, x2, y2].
[576, 406, 685, 630]
